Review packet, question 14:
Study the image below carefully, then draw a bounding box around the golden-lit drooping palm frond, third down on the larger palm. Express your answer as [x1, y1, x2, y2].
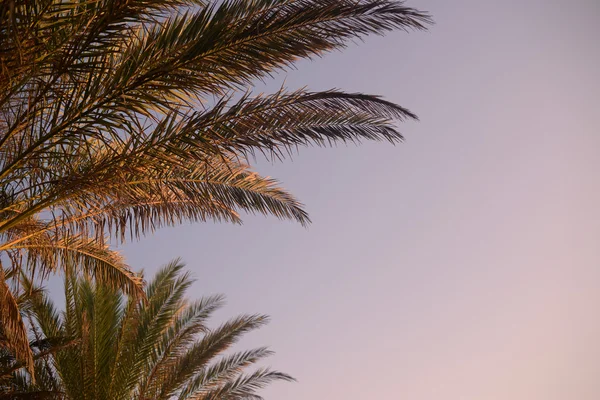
[0, 151, 308, 253]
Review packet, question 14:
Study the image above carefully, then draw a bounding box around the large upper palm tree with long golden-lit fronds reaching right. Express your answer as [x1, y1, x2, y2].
[0, 0, 430, 369]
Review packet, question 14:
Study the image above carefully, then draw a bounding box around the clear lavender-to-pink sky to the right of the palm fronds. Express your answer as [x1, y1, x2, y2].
[118, 0, 600, 400]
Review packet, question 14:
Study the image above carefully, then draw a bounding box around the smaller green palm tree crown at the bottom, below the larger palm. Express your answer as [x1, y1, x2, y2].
[0, 261, 292, 400]
